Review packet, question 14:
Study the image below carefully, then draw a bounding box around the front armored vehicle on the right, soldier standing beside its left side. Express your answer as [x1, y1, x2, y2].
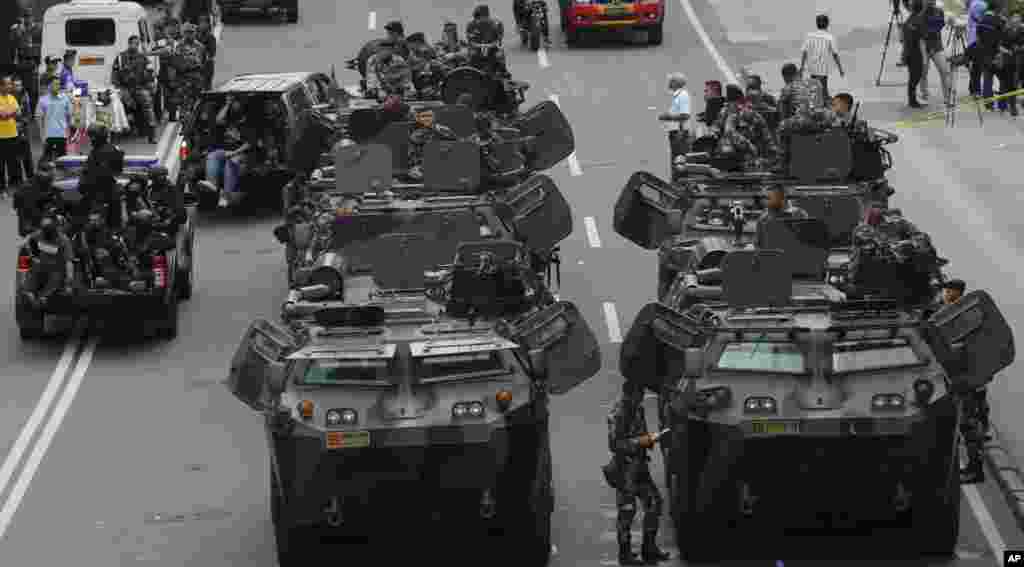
[621, 220, 1015, 561]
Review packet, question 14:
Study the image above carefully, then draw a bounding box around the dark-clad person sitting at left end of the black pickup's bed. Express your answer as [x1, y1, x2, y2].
[23, 213, 75, 305]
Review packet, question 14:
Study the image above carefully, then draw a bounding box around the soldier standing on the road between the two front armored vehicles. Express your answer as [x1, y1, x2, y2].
[608, 381, 669, 565]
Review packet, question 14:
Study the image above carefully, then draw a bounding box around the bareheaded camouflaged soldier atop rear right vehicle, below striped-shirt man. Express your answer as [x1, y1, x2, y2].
[778, 63, 840, 167]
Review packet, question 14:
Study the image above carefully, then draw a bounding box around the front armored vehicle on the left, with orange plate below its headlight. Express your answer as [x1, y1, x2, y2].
[228, 198, 601, 566]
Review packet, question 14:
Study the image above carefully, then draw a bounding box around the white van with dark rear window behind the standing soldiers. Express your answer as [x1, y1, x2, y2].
[40, 0, 160, 92]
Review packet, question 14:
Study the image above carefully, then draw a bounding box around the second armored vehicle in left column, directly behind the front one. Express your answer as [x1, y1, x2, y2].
[276, 102, 574, 282]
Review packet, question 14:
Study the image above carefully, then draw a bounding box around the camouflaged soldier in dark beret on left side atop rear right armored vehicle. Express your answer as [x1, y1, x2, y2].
[718, 85, 777, 166]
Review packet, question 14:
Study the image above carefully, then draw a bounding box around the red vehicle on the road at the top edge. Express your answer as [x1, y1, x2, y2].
[558, 0, 665, 45]
